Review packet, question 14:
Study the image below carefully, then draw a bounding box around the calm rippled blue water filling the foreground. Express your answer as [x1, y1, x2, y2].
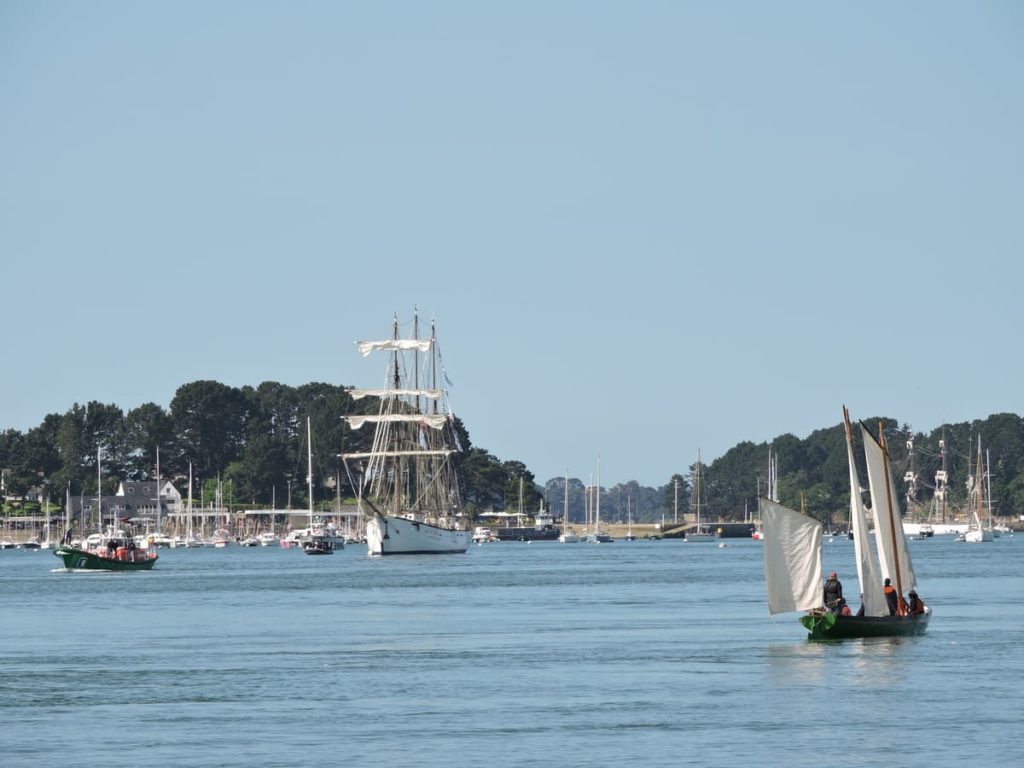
[0, 535, 1024, 768]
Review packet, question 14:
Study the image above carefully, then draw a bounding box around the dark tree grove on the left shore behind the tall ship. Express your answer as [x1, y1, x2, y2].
[0, 381, 541, 520]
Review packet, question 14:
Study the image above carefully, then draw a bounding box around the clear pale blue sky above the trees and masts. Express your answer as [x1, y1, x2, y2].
[0, 0, 1024, 485]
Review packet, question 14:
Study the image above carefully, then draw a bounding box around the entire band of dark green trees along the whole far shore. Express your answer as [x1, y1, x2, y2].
[0, 381, 1024, 522]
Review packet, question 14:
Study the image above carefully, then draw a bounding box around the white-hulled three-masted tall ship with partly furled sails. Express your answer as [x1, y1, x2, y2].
[341, 313, 472, 556]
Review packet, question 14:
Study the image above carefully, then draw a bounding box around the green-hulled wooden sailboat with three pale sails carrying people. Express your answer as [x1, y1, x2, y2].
[760, 408, 931, 639]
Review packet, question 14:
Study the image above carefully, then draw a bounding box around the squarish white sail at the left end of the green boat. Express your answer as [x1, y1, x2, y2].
[759, 498, 822, 613]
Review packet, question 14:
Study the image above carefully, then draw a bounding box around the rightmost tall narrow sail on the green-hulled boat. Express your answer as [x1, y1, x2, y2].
[860, 423, 918, 592]
